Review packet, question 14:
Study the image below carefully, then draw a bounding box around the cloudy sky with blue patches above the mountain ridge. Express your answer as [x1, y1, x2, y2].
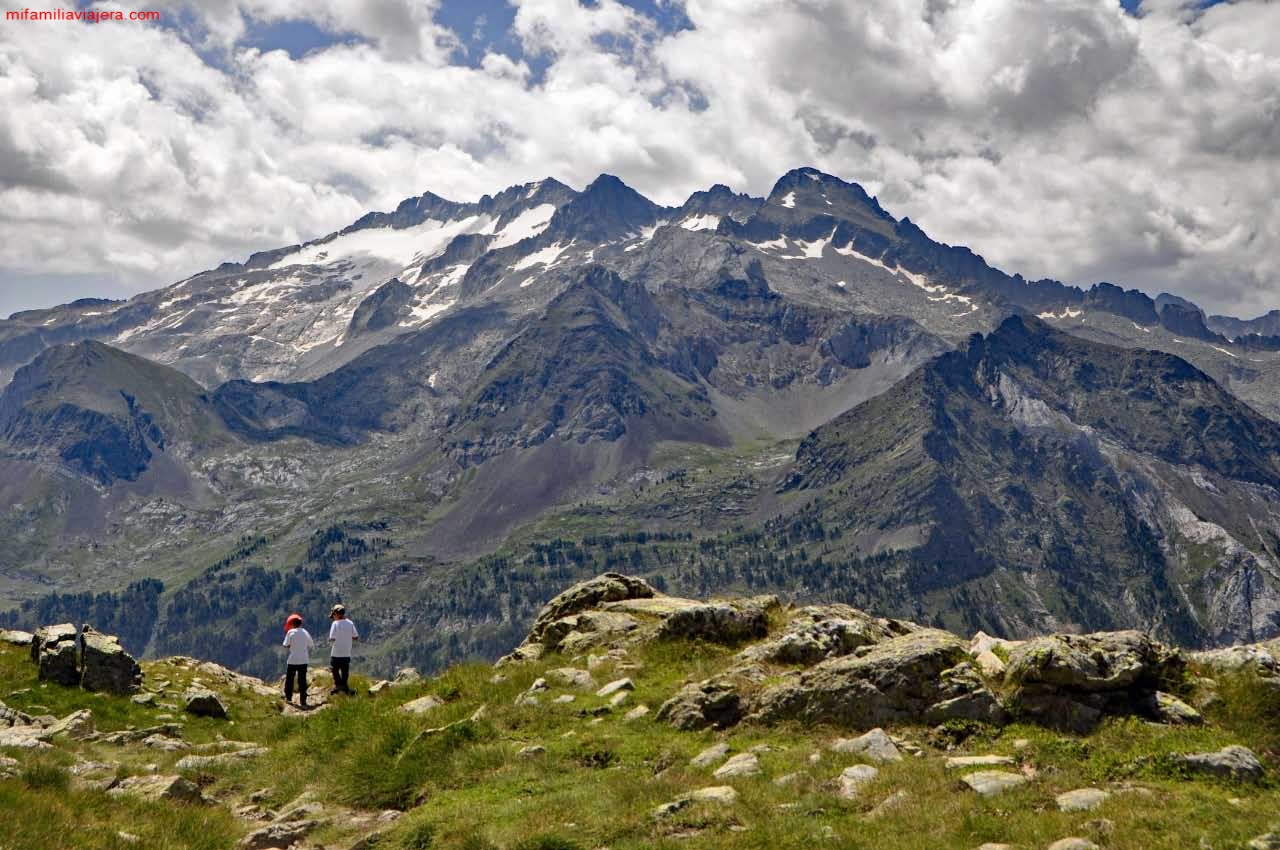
[0, 0, 1280, 315]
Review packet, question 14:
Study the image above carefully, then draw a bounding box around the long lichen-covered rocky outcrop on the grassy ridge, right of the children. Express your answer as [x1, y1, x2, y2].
[506, 573, 1218, 737]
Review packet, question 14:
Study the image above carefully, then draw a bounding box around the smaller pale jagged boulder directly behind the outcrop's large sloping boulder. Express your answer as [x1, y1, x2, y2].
[740, 604, 919, 666]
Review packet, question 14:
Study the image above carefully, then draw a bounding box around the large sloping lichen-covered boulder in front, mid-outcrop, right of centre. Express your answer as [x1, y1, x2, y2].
[750, 629, 1004, 728]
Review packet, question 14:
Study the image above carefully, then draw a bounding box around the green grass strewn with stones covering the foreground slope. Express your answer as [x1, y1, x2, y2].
[0, 629, 1280, 850]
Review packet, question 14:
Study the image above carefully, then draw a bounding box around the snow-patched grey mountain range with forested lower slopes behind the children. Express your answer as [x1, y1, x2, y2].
[0, 169, 1280, 672]
